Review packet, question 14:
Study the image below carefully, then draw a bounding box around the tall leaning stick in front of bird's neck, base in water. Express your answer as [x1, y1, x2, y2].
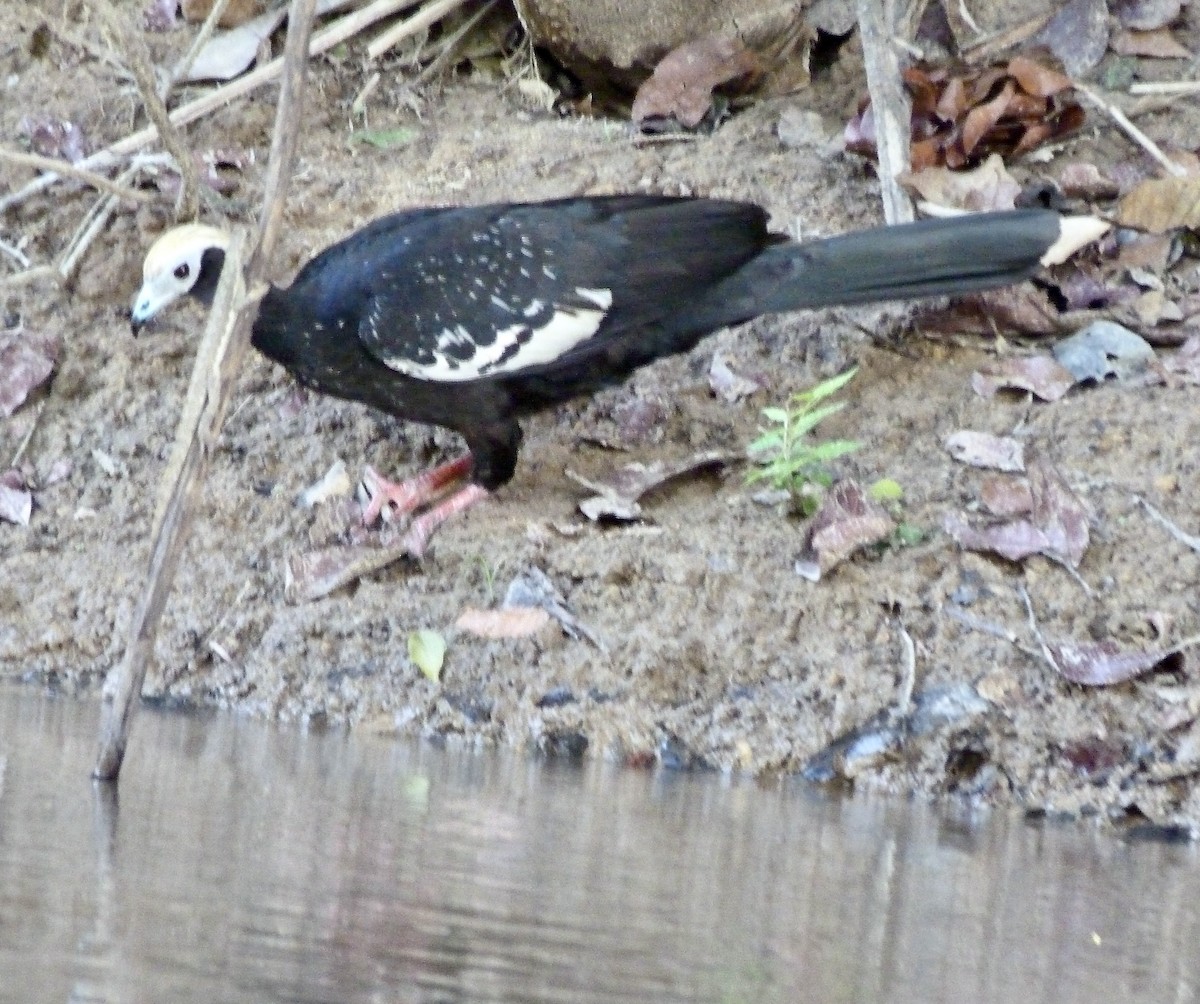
[92, 0, 316, 781]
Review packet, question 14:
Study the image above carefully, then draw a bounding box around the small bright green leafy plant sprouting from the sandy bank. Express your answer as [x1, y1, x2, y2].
[746, 366, 860, 516]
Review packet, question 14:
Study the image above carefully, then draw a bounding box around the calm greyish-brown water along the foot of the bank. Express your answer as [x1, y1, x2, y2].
[0, 691, 1200, 1004]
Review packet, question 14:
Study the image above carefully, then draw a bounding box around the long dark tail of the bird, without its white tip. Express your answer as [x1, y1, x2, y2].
[696, 210, 1063, 324]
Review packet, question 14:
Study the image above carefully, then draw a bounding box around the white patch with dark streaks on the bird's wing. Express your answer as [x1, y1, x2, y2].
[380, 287, 612, 383]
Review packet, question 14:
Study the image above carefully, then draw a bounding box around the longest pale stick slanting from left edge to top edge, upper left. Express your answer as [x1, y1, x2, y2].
[0, 0, 413, 212]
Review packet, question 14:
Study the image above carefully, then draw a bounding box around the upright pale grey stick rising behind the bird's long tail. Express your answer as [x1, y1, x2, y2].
[857, 0, 913, 223]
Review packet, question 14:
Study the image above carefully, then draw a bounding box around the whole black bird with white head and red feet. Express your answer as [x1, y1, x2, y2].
[132, 196, 1091, 554]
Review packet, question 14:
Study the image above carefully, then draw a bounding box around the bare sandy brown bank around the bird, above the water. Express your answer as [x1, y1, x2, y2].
[7, 5, 1200, 825]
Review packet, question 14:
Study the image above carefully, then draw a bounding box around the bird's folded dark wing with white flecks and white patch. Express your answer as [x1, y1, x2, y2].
[359, 197, 761, 383]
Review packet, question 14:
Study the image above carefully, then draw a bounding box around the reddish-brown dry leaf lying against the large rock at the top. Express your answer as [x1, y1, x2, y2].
[632, 36, 763, 128]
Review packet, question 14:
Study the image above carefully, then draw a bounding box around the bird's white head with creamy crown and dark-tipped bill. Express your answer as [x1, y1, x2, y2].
[130, 223, 229, 335]
